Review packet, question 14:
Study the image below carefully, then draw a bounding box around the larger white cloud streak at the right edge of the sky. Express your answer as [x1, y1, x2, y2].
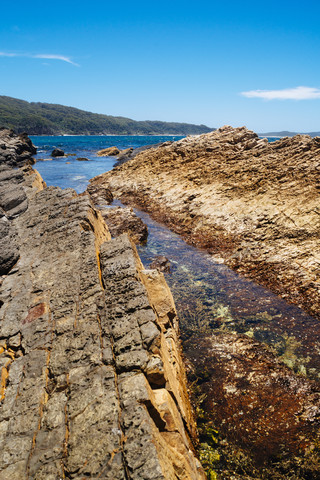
[241, 87, 320, 100]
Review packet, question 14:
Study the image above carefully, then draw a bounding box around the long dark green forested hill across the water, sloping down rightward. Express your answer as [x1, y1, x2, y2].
[0, 96, 213, 135]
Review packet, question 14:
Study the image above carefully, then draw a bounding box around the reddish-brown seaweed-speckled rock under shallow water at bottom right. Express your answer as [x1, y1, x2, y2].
[184, 332, 320, 480]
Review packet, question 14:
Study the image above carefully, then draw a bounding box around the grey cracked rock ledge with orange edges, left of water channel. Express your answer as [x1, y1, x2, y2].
[0, 130, 205, 480]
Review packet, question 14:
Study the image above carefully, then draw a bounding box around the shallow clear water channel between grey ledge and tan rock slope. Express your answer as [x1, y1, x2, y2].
[125, 202, 320, 379]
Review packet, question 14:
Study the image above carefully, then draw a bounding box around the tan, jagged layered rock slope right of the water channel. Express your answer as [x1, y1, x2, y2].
[92, 126, 320, 316]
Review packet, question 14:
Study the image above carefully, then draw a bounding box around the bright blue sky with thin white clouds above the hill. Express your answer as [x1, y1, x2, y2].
[0, 0, 320, 132]
